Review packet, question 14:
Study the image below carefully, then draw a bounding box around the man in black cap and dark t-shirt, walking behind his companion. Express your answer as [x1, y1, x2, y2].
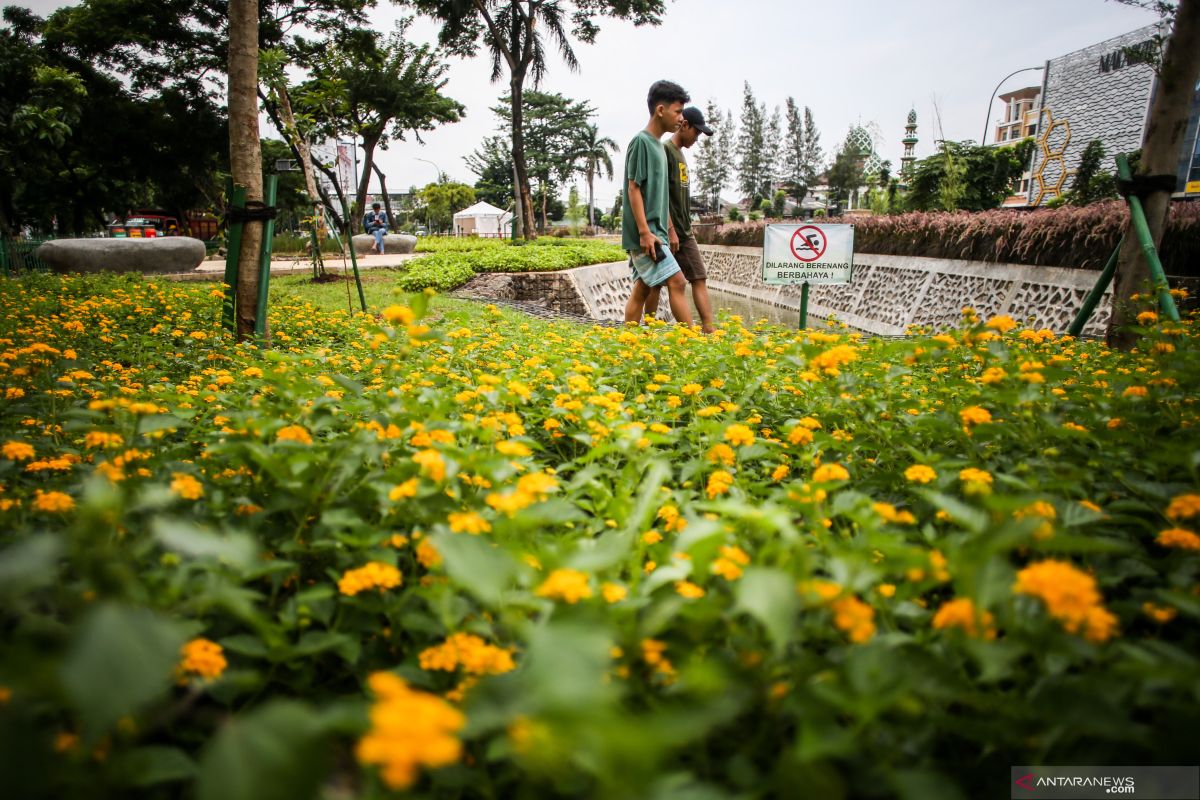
[646, 106, 714, 333]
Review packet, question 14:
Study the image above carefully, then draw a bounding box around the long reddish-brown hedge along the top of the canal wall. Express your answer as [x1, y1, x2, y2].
[696, 200, 1200, 276]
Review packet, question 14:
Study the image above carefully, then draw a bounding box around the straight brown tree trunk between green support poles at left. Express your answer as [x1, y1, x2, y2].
[228, 0, 263, 342]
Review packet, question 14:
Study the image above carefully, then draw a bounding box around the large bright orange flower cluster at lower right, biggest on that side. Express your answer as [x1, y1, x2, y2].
[1013, 559, 1117, 642]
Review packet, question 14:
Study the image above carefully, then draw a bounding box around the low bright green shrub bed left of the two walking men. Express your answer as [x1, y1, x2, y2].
[398, 239, 626, 291]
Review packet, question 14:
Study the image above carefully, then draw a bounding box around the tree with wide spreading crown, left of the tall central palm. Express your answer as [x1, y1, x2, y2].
[294, 19, 466, 226]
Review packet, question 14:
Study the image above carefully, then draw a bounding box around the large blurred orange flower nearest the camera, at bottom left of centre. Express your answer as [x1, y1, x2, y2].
[354, 671, 467, 789]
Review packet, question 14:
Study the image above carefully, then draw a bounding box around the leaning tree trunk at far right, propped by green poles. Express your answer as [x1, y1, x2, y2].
[1106, 0, 1200, 349]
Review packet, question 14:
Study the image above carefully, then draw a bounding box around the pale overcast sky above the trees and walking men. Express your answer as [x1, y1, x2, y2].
[16, 0, 1158, 206]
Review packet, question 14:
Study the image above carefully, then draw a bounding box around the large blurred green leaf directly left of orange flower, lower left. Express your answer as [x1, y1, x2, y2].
[61, 604, 186, 736]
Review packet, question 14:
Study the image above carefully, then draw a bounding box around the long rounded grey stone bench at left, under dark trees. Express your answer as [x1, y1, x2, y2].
[37, 236, 204, 275]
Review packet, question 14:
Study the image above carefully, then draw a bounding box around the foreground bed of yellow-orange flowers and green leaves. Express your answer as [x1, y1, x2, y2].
[0, 276, 1200, 799]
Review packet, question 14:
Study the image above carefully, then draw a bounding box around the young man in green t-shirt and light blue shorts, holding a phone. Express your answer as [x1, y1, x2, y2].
[620, 80, 691, 325]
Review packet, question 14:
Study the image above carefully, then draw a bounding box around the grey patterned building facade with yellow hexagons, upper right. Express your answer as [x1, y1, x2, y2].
[1026, 25, 1200, 206]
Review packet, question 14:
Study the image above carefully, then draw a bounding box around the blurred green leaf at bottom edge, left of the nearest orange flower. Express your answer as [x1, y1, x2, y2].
[197, 700, 325, 800]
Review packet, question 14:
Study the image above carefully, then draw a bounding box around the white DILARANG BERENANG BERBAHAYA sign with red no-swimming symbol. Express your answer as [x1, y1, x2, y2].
[762, 224, 854, 284]
